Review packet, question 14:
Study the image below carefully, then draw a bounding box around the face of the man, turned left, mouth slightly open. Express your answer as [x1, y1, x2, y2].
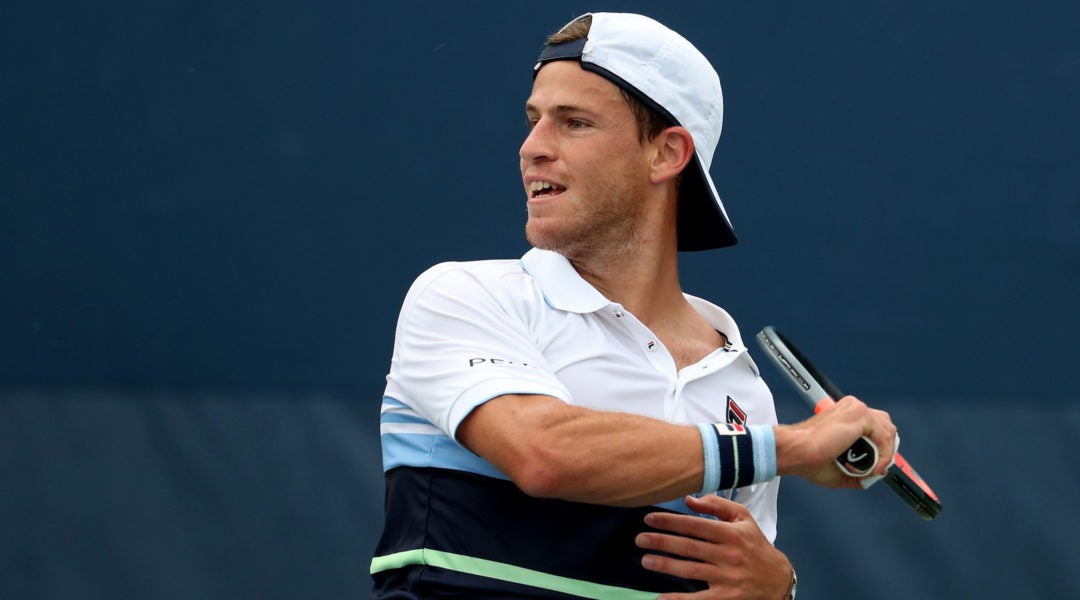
[519, 60, 650, 258]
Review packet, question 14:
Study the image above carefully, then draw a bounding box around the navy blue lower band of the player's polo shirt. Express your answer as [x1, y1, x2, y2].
[372, 466, 705, 600]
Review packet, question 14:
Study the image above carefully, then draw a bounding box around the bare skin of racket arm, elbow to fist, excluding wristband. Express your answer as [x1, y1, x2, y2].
[457, 395, 895, 506]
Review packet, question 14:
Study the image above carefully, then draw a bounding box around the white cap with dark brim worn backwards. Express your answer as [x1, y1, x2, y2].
[534, 13, 738, 250]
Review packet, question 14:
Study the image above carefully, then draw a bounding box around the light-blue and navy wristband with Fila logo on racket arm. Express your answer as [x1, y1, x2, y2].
[698, 423, 777, 494]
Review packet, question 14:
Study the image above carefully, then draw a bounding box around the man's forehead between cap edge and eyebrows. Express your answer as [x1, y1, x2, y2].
[526, 60, 630, 111]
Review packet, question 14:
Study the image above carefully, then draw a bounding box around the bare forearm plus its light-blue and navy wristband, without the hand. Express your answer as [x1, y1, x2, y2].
[458, 396, 772, 506]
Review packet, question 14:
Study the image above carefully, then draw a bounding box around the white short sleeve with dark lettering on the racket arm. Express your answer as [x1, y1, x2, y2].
[387, 261, 570, 438]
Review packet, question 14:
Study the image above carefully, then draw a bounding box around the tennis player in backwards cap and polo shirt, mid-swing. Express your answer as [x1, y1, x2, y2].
[372, 13, 895, 600]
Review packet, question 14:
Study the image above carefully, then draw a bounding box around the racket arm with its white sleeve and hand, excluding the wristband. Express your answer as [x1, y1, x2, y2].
[397, 263, 895, 498]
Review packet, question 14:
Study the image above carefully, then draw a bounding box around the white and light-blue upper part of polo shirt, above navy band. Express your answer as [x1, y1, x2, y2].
[381, 249, 779, 541]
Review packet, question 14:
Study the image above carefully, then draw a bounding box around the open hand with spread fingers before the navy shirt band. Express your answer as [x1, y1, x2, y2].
[636, 494, 794, 600]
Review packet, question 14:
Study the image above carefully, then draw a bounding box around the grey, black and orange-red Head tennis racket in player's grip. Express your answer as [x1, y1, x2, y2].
[757, 326, 942, 521]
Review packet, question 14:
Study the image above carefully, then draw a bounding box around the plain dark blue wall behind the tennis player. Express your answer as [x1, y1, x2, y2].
[0, 0, 1080, 599]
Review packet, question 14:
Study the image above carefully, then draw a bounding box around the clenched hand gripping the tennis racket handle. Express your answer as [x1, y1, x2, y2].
[774, 396, 896, 488]
